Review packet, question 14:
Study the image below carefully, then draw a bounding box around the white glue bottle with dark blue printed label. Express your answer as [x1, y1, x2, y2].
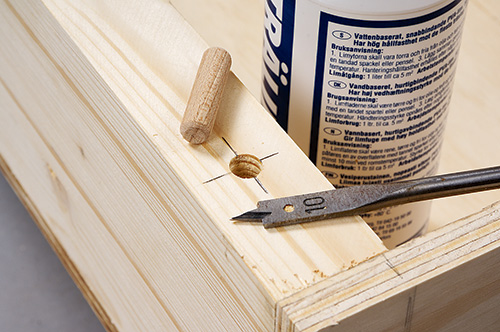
[262, 0, 467, 248]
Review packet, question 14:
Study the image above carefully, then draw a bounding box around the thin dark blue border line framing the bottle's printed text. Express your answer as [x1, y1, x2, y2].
[309, 0, 463, 164]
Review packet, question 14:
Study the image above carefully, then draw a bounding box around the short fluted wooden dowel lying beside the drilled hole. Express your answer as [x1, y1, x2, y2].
[180, 47, 231, 144]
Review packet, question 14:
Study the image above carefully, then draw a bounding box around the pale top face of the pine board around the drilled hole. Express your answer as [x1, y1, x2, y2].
[40, 1, 380, 292]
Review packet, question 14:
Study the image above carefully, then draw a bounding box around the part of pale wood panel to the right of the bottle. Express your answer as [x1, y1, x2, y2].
[430, 0, 500, 229]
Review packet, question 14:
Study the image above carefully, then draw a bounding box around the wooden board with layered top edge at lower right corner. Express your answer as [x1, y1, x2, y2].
[276, 202, 500, 332]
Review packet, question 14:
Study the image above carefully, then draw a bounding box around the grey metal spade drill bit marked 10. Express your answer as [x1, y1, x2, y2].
[232, 166, 500, 228]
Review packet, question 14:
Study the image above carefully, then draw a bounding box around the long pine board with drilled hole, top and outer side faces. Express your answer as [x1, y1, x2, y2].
[0, 1, 386, 331]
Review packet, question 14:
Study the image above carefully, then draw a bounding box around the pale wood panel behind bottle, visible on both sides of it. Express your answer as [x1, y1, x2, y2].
[171, 0, 500, 230]
